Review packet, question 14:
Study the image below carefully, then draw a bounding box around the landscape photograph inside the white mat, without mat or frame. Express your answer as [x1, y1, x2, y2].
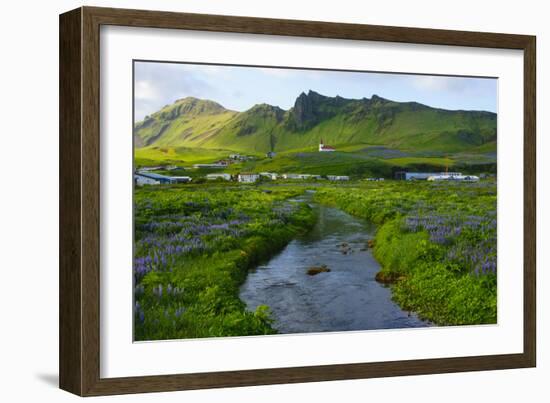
[133, 60, 500, 342]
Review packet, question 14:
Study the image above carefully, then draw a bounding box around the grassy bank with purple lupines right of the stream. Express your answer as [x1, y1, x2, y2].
[315, 181, 497, 325]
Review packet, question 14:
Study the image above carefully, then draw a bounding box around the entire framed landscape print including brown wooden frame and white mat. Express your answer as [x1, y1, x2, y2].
[60, 7, 536, 396]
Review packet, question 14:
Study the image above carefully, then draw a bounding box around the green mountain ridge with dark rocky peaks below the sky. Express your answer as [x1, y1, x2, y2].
[134, 91, 497, 153]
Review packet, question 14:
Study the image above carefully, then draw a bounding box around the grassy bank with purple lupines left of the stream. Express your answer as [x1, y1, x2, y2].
[134, 185, 314, 340]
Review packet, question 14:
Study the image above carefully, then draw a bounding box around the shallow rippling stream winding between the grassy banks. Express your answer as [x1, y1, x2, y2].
[240, 196, 428, 333]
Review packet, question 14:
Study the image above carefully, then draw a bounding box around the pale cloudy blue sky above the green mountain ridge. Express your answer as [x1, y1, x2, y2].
[134, 62, 497, 121]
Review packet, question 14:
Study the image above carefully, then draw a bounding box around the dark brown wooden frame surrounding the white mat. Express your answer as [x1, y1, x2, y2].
[59, 7, 536, 396]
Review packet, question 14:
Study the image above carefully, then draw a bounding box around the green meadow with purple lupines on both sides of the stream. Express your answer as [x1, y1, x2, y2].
[133, 181, 497, 341]
